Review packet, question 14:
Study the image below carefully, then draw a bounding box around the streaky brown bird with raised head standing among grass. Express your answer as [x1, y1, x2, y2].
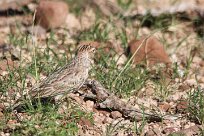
[13, 42, 96, 109]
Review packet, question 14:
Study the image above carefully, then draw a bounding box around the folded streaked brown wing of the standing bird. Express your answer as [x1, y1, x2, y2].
[30, 67, 85, 97]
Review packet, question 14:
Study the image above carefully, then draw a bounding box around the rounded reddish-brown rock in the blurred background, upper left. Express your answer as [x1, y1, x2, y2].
[35, 0, 68, 30]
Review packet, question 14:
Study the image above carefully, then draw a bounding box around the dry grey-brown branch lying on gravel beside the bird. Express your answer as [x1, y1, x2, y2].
[83, 80, 167, 121]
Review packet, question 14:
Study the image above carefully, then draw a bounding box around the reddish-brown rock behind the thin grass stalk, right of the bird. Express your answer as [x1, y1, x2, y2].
[128, 36, 171, 66]
